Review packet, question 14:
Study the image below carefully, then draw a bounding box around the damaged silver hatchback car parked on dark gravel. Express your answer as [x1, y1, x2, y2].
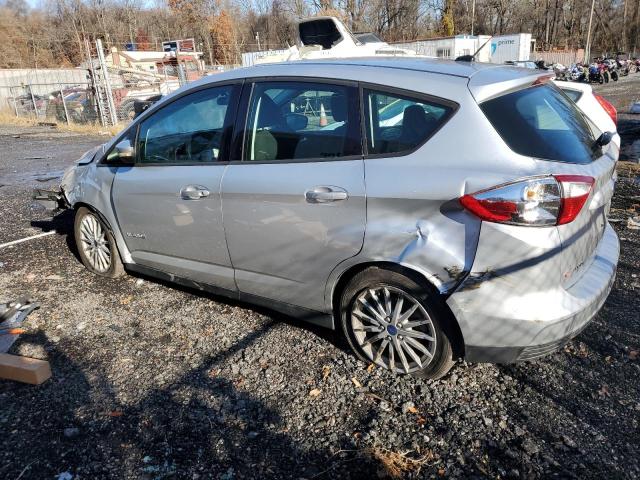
[55, 57, 619, 378]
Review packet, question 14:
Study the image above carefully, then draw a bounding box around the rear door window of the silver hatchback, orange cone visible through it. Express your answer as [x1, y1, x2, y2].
[244, 81, 362, 162]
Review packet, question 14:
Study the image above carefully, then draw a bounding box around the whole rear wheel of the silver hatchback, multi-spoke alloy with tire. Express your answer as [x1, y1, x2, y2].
[342, 268, 454, 379]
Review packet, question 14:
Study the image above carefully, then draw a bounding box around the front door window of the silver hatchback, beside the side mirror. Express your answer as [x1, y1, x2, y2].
[138, 85, 235, 165]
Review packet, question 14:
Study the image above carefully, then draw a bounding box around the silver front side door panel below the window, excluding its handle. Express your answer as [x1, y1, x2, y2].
[112, 164, 236, 290]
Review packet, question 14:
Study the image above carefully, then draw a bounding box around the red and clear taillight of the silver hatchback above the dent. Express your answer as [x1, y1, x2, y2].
[459, 175, 594, 226]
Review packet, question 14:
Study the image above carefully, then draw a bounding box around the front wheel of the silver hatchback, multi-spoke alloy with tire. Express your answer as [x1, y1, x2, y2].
[74, 207, 124, 278]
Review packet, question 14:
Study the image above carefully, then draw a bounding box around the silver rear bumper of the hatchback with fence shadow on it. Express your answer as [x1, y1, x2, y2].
[447, 223, 620, 363]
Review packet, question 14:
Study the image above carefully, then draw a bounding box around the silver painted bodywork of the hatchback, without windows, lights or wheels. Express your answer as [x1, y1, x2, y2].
[58, 57, 618, 361]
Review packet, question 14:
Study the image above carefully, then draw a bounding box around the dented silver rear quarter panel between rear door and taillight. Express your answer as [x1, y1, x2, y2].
[325, 96, 535, 308]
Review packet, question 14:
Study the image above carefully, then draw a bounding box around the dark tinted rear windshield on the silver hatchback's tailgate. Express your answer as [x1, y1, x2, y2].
[480, 84, 601, 163]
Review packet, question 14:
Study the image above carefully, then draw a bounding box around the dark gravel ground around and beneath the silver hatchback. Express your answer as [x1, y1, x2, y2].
[0, 75, 640, 480]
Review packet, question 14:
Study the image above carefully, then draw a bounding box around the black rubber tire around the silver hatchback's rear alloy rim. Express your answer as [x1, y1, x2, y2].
[339, 267, 455, 380]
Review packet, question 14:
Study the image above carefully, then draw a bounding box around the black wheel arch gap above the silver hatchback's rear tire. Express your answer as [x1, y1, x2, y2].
[331, 261, 465, 358]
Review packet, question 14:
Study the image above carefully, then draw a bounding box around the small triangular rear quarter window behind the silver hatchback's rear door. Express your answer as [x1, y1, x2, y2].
[364, 89, 453, 154]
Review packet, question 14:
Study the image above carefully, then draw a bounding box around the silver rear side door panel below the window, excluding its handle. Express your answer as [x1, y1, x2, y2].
[222, 159, 366, 311]
